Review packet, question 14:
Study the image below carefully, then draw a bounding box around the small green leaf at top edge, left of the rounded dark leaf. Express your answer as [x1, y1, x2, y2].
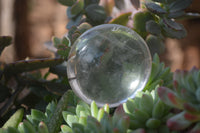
[71, 0, 84, 15]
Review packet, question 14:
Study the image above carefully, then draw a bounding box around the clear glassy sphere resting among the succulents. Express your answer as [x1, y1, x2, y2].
[67, 24, 151, 107]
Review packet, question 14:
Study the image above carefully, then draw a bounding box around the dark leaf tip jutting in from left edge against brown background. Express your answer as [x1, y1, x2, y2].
[0, 36, 12, 55]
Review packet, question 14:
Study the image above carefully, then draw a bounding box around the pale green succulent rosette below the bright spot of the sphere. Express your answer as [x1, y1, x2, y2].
[123, 86, 174, 133]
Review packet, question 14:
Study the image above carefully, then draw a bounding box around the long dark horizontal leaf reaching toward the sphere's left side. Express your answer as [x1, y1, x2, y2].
[4, 58, 64, 75]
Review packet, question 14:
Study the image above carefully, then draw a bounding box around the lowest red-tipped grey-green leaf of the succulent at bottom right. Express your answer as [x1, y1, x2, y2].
[167, 112, 192, 130]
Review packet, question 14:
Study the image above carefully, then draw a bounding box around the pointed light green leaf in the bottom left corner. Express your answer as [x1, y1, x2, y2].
[2, 109, 24, 128]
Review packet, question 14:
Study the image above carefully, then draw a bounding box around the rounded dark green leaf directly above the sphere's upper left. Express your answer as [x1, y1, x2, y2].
[85, 4, 107, 25]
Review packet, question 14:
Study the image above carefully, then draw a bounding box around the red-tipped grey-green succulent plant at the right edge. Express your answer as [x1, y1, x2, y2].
[158, 67, 200, 133]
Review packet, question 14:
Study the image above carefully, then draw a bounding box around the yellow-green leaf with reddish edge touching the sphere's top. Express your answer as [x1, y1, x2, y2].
[109, 12, 132, 26]
